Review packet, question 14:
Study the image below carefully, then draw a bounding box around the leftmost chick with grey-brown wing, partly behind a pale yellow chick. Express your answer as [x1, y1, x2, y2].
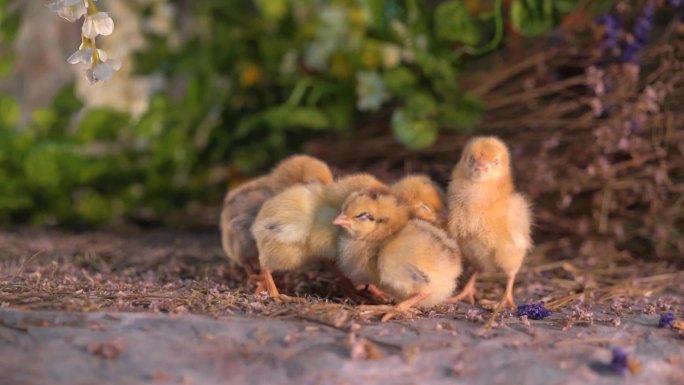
[220, 155, 333, 284]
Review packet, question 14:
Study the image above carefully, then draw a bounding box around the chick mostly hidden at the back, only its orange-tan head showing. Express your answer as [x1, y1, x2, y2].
[390, 175, 447, 226]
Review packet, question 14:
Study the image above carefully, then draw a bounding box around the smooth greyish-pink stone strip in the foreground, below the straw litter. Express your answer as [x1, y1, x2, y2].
[0, 309, 684, 385]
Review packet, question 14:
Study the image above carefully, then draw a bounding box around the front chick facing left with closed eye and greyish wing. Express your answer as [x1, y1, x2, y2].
[334, 189, 461, 322]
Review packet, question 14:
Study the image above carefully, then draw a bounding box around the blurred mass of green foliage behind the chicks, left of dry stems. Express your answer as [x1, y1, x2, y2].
[0, 0, 588, 224]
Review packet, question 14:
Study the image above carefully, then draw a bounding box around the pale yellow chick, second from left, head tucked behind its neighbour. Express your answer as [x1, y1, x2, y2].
[252, 174, 385, 300]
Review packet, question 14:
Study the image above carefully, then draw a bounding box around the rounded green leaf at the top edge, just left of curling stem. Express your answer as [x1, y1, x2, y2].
[435, 0, 480, 46]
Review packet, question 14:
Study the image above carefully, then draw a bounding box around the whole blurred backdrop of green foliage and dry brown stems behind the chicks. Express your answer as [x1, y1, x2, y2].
[0, 0, 684, 261]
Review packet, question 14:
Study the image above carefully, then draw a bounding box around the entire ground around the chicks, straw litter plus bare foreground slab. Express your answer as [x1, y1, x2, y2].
[0, 230, 684, 385]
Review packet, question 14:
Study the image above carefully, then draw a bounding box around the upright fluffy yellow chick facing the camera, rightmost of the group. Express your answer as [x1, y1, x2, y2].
[447, 137, 532, 308]
